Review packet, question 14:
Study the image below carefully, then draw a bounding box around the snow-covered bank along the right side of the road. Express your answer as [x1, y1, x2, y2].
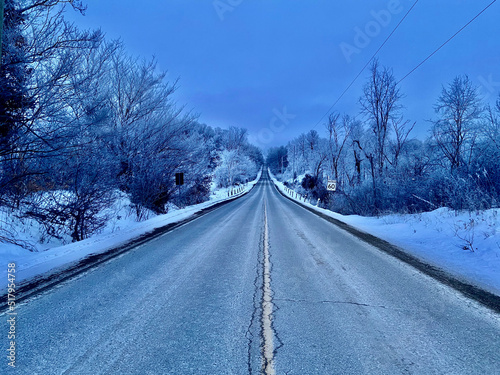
[271, 170, 500, 295]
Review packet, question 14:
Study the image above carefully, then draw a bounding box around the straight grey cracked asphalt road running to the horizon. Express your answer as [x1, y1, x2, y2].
[0, 172, 500, 375]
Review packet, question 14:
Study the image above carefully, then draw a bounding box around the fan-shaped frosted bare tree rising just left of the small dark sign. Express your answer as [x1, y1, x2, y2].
[108, 49, 189, 185]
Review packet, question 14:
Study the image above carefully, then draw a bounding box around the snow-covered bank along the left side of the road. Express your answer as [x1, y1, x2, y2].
[0, 171, 262, 293]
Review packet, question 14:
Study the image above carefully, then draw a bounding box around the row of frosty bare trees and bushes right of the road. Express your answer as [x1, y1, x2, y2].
[267, 61, 500, 215]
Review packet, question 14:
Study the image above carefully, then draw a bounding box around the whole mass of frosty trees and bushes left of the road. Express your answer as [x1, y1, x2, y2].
[0, 0, 263, 245]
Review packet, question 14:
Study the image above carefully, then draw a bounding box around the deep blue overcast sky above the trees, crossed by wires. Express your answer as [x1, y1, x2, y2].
[67, 0, 500, 148]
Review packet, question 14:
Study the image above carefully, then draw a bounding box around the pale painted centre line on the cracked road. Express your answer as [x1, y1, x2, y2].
[262, 205, 276, 375]
